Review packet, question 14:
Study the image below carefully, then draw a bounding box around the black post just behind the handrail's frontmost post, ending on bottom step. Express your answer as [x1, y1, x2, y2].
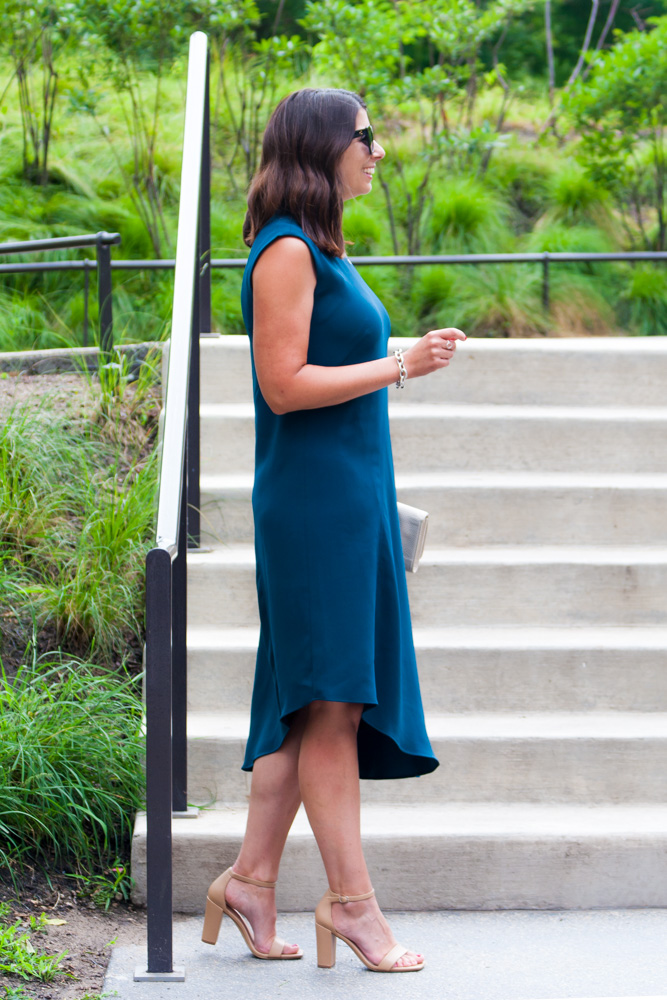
[171, 447, 188, 812]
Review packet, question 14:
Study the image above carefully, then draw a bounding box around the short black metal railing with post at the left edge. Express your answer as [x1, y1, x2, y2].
[0, 232, 120, 354]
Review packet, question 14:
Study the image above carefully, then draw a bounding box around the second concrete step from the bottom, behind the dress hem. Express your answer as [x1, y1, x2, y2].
[188, 711, 667, 807]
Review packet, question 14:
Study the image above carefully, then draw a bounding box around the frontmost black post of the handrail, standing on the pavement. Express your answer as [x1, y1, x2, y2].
[146, 548, 173, 973]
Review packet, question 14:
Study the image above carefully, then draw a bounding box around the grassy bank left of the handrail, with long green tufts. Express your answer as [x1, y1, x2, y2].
[0, 355, 159, 876]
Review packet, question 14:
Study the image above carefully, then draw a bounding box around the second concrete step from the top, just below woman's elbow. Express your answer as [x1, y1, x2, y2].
[201, 403, 667, 475]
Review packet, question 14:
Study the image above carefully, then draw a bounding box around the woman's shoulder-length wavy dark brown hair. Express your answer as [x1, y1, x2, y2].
[243, 87, 366, 257]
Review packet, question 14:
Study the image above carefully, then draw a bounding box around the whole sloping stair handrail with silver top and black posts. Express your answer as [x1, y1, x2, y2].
[142, 32, 211, 980]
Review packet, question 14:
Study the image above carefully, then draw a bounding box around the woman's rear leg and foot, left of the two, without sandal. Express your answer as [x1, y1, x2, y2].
[226, 719, 303, 954]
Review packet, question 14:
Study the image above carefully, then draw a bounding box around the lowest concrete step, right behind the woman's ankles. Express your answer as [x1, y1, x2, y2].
[132, 800, 667, 913]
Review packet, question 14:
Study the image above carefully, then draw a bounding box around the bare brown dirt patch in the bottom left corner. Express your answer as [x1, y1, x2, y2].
[0, 870, 146, 1000]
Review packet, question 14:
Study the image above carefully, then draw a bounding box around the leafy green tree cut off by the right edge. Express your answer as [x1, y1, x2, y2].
[566, 17, 667, 250]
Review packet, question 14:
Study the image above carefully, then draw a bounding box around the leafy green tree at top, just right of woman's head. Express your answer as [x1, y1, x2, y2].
[301, 0, 530, 254]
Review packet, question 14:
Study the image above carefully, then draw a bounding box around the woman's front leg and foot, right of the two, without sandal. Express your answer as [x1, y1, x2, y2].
[298, 701, 422, 965]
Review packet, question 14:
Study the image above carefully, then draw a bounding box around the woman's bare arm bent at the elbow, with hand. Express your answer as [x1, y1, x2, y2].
[253, 236, 465, 414]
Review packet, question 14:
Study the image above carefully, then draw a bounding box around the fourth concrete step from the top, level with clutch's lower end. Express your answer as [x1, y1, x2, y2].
[188, 546, 667, 628]
